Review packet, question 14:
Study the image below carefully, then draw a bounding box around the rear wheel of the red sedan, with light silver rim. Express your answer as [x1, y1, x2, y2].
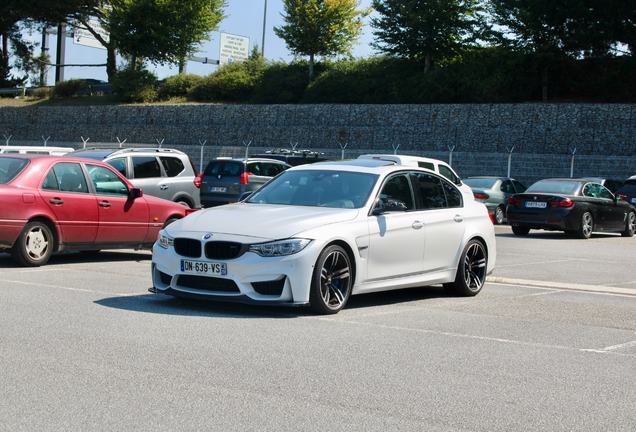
[11, 221, 55, 267]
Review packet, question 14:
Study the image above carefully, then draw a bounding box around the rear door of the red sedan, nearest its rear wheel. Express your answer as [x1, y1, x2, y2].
[39, 162, 99, 246]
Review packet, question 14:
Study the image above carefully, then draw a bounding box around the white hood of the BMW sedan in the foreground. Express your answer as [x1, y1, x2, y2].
[174, 203, 359, 240]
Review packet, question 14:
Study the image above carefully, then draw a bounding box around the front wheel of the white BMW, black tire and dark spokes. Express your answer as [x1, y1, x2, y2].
[309, 245, 353, 315]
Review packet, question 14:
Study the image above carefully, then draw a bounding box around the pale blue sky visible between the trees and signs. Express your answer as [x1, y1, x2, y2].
[30, 0, 373, 85]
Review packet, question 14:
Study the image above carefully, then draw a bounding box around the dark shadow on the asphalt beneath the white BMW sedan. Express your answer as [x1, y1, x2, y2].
[95, 286, 452, 318]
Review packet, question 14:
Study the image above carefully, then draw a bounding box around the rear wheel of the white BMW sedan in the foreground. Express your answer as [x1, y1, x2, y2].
[444, 240, 488, 297]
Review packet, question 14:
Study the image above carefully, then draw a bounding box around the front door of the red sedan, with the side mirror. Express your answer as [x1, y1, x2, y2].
[86, 164, 149, 247]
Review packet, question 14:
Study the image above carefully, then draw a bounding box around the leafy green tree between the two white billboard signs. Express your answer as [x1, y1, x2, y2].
[106, 0, 225, 69]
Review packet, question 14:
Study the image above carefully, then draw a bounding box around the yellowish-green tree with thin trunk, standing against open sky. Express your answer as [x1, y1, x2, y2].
[274, 0, 371, 80]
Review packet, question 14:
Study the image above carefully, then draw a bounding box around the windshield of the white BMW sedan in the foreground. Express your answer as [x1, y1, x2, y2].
[246, 170, 378, 208]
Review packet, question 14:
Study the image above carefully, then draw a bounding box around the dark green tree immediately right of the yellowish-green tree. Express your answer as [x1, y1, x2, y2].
[371, 0, 489, 73]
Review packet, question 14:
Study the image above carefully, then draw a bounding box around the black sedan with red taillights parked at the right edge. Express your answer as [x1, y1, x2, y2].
[508, 178, 636, 239]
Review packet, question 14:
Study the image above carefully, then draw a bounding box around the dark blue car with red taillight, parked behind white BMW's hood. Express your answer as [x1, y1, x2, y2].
[197, 158, 291, 208]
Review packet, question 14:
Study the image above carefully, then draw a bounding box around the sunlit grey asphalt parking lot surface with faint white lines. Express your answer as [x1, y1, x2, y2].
[0, 227, 636, 431]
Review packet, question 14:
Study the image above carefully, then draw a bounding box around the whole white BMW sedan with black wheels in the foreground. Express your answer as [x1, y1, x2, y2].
[152, 159, 496, 314]
